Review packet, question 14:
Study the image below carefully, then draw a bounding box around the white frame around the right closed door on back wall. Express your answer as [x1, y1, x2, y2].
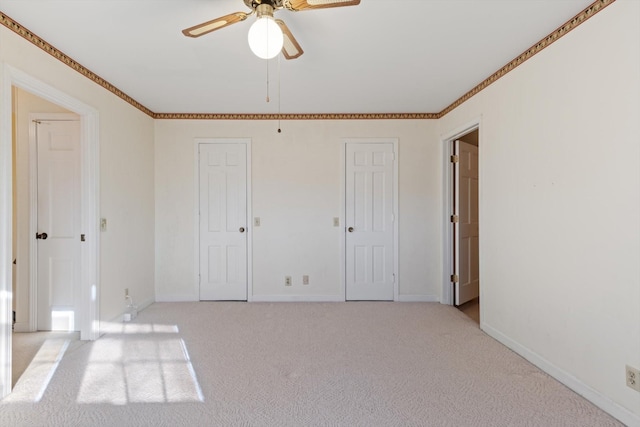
[340, 138, 400, 301]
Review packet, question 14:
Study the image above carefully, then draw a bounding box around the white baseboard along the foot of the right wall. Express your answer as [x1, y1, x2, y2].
[481, 323, 640, 426]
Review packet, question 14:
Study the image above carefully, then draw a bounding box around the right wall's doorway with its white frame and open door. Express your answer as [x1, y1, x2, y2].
[443, 123, 480, 324]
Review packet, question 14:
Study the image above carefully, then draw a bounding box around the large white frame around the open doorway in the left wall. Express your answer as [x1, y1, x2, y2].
[0, 63, 100, 398]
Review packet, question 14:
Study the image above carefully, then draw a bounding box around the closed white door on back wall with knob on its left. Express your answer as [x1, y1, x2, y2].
[345, 143, 395, 301]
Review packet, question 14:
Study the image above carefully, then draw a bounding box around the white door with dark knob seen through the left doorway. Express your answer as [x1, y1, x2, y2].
[34, 121, 80, 331]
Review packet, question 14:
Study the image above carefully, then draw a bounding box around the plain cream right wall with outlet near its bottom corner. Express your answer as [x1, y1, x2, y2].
[439, 0, 640, 425]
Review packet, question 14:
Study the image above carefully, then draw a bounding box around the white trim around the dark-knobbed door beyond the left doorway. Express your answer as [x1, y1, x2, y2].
[28, 113, 80, 332]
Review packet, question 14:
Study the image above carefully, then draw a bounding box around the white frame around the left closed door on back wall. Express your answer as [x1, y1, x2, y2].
[193, 138, 253, 302]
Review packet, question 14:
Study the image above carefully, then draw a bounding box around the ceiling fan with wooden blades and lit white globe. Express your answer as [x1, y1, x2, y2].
[182, 0, 360, 59]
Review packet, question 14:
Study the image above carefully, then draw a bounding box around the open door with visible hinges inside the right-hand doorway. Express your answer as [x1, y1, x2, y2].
[454, 141, 480, 305]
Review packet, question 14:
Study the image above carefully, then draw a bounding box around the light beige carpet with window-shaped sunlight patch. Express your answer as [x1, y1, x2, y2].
[0, 302, 621, 427]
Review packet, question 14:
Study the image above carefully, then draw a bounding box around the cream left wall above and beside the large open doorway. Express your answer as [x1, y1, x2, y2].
[0, 26, 154, 328]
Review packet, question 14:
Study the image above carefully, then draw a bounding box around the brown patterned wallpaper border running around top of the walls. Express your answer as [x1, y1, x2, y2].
[0, 0, 616, 120]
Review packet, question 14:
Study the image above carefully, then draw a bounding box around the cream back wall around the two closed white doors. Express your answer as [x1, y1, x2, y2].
[155, 120, 442, 300]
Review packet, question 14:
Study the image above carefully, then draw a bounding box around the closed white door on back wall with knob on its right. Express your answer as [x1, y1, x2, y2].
[198, 143, 248, 301]
